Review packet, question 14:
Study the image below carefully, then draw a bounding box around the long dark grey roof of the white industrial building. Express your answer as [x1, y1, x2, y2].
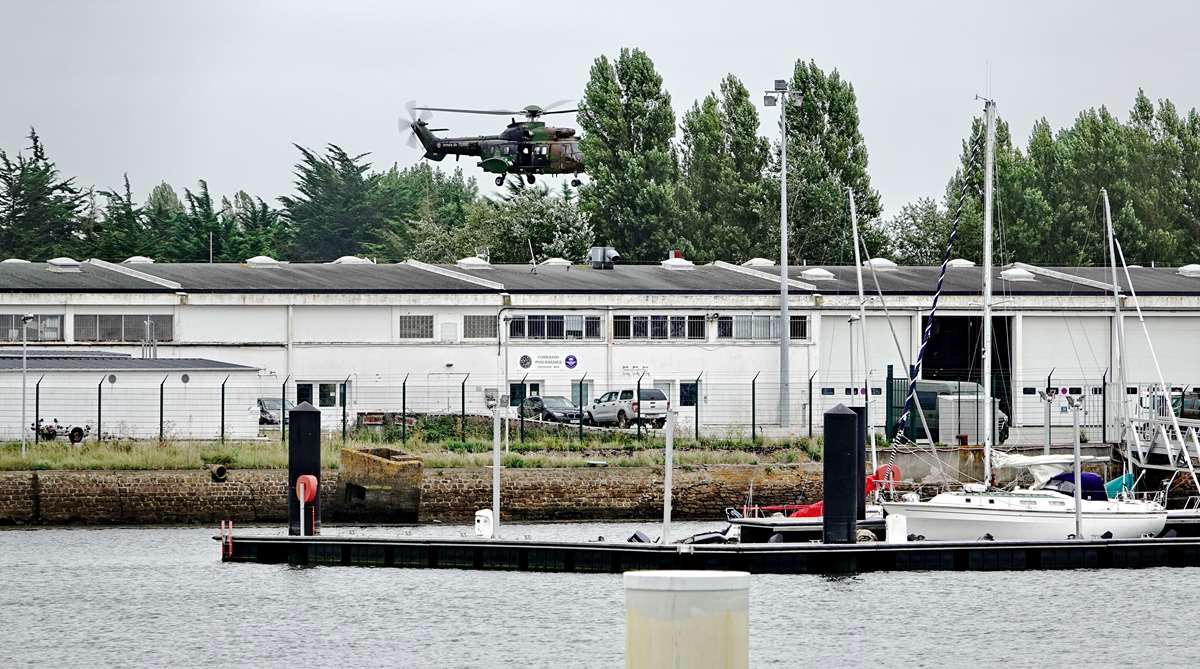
[0, 263, 1200, 295]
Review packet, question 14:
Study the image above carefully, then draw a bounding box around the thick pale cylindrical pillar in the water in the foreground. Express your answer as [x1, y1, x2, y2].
[625, 571, 750, 669]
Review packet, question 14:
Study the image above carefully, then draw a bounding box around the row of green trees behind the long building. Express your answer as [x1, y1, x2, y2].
[0, 49, 1200, 265]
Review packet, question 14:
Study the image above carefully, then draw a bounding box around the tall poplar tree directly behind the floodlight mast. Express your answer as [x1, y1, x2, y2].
[786, 60, 888, 264]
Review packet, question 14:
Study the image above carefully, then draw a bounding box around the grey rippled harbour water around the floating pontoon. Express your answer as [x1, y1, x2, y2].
[0, 523, 1200, 668]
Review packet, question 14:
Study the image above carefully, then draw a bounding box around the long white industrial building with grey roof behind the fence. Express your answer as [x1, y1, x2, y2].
[0, 258, 1200, 443]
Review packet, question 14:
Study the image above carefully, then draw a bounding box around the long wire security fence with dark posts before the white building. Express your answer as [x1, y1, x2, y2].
[0, 372, 1185, 444]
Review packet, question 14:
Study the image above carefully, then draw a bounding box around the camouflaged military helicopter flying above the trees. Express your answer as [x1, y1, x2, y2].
[400, 100, 583, 186]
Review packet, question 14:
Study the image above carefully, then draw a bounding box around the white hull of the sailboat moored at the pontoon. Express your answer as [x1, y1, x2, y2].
[883, 493, 1166, 541]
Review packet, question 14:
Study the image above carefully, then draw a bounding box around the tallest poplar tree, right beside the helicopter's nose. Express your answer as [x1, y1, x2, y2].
[577, 49, 685, 261]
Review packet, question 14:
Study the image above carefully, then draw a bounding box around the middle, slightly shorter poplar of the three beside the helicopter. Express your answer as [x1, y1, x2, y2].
[679, 74, 779, 261]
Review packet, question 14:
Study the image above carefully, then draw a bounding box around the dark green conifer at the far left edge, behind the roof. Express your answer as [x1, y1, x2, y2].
[0, 128, 86, 260]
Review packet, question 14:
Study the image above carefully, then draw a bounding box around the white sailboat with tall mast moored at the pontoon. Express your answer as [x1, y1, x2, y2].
[883, 100, 1166, 541]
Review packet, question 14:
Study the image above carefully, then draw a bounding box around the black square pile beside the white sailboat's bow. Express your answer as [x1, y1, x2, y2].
[821, 404, 863, 543]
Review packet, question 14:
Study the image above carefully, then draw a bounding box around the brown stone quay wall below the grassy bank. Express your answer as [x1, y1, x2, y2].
[0, 464, 821, 525]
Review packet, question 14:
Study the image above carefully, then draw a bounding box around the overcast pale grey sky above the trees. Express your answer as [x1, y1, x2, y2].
[0, 0, 1200, 216]
